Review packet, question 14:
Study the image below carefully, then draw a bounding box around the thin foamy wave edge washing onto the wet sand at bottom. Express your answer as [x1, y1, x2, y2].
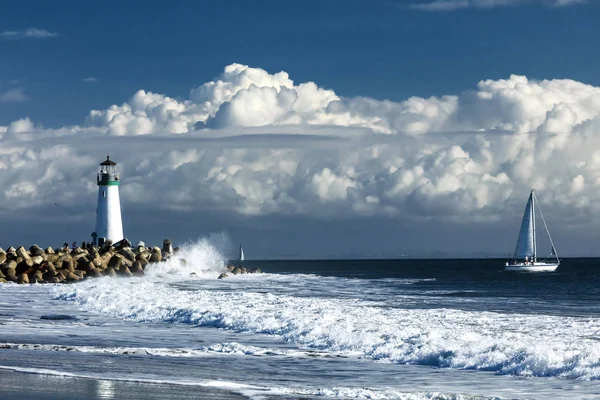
[0, 365, 501, 400]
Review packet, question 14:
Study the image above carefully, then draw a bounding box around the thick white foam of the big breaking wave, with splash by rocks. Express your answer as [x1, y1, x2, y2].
[50, 241, 600, 380]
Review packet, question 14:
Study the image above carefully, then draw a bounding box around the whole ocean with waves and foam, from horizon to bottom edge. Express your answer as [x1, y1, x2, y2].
[0, 241, 600, 400]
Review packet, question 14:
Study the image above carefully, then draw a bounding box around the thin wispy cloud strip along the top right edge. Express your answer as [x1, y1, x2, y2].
[410, 0, 588, 11]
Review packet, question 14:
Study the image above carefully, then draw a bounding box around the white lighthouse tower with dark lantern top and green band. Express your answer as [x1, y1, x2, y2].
[92, 156, 123, 245]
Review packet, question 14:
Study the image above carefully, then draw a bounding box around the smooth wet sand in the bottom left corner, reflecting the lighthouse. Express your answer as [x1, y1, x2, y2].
[0, 370, 247, 400]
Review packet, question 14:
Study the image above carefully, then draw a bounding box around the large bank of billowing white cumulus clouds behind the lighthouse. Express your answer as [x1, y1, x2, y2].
[0, 64, 600, 234]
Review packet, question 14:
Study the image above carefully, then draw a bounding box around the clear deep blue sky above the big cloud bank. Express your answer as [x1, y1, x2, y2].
[0, 0, 600, 127]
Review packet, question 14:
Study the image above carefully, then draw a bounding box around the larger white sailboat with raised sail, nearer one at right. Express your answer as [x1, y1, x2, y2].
[504, 190, 560, 272]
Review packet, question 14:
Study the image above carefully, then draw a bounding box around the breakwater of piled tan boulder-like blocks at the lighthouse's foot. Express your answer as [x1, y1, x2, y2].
[0, 239, 261, 284]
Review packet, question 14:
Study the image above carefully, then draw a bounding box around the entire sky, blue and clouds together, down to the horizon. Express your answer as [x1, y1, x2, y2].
[0, 0, 600, 258]
